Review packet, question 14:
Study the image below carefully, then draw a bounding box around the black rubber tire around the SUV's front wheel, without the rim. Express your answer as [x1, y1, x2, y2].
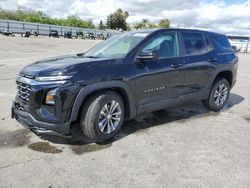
[80, 91, 124, 142]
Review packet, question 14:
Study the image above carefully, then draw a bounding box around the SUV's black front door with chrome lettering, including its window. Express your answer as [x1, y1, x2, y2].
[136, 32, 184, 111]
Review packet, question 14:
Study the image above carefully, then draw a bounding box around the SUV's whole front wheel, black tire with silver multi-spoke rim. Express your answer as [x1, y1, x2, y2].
[80, 92, 124, 142]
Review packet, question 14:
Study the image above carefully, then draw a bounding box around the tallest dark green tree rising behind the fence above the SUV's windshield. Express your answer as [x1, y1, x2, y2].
[106, 9, 129, 30]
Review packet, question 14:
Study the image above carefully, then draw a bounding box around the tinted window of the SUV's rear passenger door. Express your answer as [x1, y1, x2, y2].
[182, 32, 207, 55]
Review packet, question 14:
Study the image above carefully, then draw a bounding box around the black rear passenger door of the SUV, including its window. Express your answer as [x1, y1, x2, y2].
[181, 31, 217, 95]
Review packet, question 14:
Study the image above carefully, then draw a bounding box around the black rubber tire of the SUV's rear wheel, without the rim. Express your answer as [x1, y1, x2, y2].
[203, 77, 230, 112]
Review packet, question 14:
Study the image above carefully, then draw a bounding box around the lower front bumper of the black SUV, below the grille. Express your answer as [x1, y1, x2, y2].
[11, 102, 71, 137]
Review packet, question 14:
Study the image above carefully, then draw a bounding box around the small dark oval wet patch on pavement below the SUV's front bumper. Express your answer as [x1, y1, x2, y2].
[28, 142, 62, 154]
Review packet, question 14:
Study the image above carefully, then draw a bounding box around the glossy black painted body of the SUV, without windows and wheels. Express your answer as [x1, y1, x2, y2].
[12, 29, 238, 134]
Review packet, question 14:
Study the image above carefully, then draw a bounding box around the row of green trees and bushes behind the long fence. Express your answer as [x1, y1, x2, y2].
[0, 7, 170, 31]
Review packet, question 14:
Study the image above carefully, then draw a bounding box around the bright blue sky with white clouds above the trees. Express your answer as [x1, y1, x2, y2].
[0, 0, 250, 36]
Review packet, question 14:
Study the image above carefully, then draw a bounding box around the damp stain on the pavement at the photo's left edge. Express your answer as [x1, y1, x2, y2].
[0, 129, 31, 147]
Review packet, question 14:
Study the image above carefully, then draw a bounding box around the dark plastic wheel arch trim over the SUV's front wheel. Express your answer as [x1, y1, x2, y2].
[70, 81, 136, 122]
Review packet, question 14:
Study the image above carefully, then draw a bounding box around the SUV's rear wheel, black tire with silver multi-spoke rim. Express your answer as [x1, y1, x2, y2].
[203, 77, 230, 112]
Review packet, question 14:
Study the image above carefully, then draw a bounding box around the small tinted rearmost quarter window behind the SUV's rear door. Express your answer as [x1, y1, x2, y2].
[209, 35, 232, 51]
